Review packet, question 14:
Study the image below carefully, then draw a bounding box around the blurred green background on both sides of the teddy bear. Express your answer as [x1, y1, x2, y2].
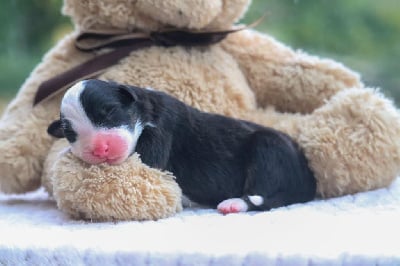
[0, 0, 400, 110]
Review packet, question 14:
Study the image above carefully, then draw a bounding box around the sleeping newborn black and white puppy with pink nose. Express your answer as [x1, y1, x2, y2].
[48, 80, 316, 213]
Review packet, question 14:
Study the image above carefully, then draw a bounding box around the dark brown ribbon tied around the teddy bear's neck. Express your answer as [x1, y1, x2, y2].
[33, 15, 265, 106]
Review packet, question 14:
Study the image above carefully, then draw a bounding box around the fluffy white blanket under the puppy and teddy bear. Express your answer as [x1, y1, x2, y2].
[0, 178, 400, 265]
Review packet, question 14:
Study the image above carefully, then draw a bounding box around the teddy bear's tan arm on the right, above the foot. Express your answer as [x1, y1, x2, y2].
[222, 30, 362, 113]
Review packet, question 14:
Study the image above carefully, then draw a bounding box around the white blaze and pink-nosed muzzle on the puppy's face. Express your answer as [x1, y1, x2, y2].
[61, 81, 143, 164]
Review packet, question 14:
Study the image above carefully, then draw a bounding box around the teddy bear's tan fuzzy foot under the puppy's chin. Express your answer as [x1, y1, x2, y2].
[52, 153, 182, 221]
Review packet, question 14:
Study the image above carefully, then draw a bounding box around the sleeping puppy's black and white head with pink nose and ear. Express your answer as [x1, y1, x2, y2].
[47, 80, 143, 164]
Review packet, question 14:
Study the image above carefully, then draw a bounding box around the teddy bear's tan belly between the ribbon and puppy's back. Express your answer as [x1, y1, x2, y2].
[100, 46, 255, 117]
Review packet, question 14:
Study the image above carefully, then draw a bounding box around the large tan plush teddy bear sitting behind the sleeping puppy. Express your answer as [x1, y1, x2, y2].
[0, 0, 400, 220]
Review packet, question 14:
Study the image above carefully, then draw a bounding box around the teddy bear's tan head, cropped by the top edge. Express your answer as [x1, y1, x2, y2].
[63, 0, 251, 31]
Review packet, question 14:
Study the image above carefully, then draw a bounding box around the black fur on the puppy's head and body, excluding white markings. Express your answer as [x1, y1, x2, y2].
[50, 80, 316, 210]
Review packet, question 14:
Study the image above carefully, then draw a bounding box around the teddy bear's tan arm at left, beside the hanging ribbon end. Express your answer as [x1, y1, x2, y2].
[0, 32, 91, 193]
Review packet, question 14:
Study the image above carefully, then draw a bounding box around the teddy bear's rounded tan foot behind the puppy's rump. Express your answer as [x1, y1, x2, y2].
[298, 89, 400, 197]
